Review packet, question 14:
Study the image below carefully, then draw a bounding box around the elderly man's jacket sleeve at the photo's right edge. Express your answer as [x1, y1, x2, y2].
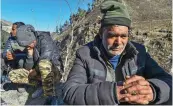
[144, 53, 172, 104]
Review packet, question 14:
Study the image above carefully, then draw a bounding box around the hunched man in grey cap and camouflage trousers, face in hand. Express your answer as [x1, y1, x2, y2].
[9, 25, 62, 105]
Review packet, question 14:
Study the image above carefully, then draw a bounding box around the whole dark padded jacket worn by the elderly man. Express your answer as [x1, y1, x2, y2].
[63, 37, 172, 105]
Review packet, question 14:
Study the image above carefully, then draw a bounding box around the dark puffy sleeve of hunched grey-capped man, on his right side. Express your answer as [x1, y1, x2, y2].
[38, 32, 63, 71]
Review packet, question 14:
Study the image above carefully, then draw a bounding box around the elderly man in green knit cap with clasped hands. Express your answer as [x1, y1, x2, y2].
[63, 0, 172, 105]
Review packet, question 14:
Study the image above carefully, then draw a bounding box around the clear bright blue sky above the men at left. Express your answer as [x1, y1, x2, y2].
[1, 0, 92, 32]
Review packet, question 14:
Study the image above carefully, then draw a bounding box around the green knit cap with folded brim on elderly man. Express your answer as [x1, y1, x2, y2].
[100, 0, 131, 27]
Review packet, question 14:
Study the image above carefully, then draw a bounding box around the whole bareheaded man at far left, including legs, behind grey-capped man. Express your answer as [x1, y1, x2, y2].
[1, 22, 28, 91]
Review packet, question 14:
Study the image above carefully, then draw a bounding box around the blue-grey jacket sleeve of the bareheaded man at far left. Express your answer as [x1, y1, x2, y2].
[2, 37, 12, 59]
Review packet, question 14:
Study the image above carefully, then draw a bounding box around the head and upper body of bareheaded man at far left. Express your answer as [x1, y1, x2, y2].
[2, 22, 26, 69]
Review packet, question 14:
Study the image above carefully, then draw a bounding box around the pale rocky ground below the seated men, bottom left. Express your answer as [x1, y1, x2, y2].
[1, 84, 63, 105]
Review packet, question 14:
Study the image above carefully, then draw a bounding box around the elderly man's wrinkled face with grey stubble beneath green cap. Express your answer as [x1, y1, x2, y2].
[102, 25, 128, 56]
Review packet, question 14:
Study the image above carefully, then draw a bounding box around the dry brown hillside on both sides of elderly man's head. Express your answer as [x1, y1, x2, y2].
[57, 0, 172, 81]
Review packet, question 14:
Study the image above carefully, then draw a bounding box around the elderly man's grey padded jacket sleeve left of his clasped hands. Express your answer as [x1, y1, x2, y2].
[63, 49, 118, 105]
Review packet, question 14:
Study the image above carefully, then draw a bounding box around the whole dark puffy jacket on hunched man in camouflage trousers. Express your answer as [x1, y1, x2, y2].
[26, 31, 62, 71]
